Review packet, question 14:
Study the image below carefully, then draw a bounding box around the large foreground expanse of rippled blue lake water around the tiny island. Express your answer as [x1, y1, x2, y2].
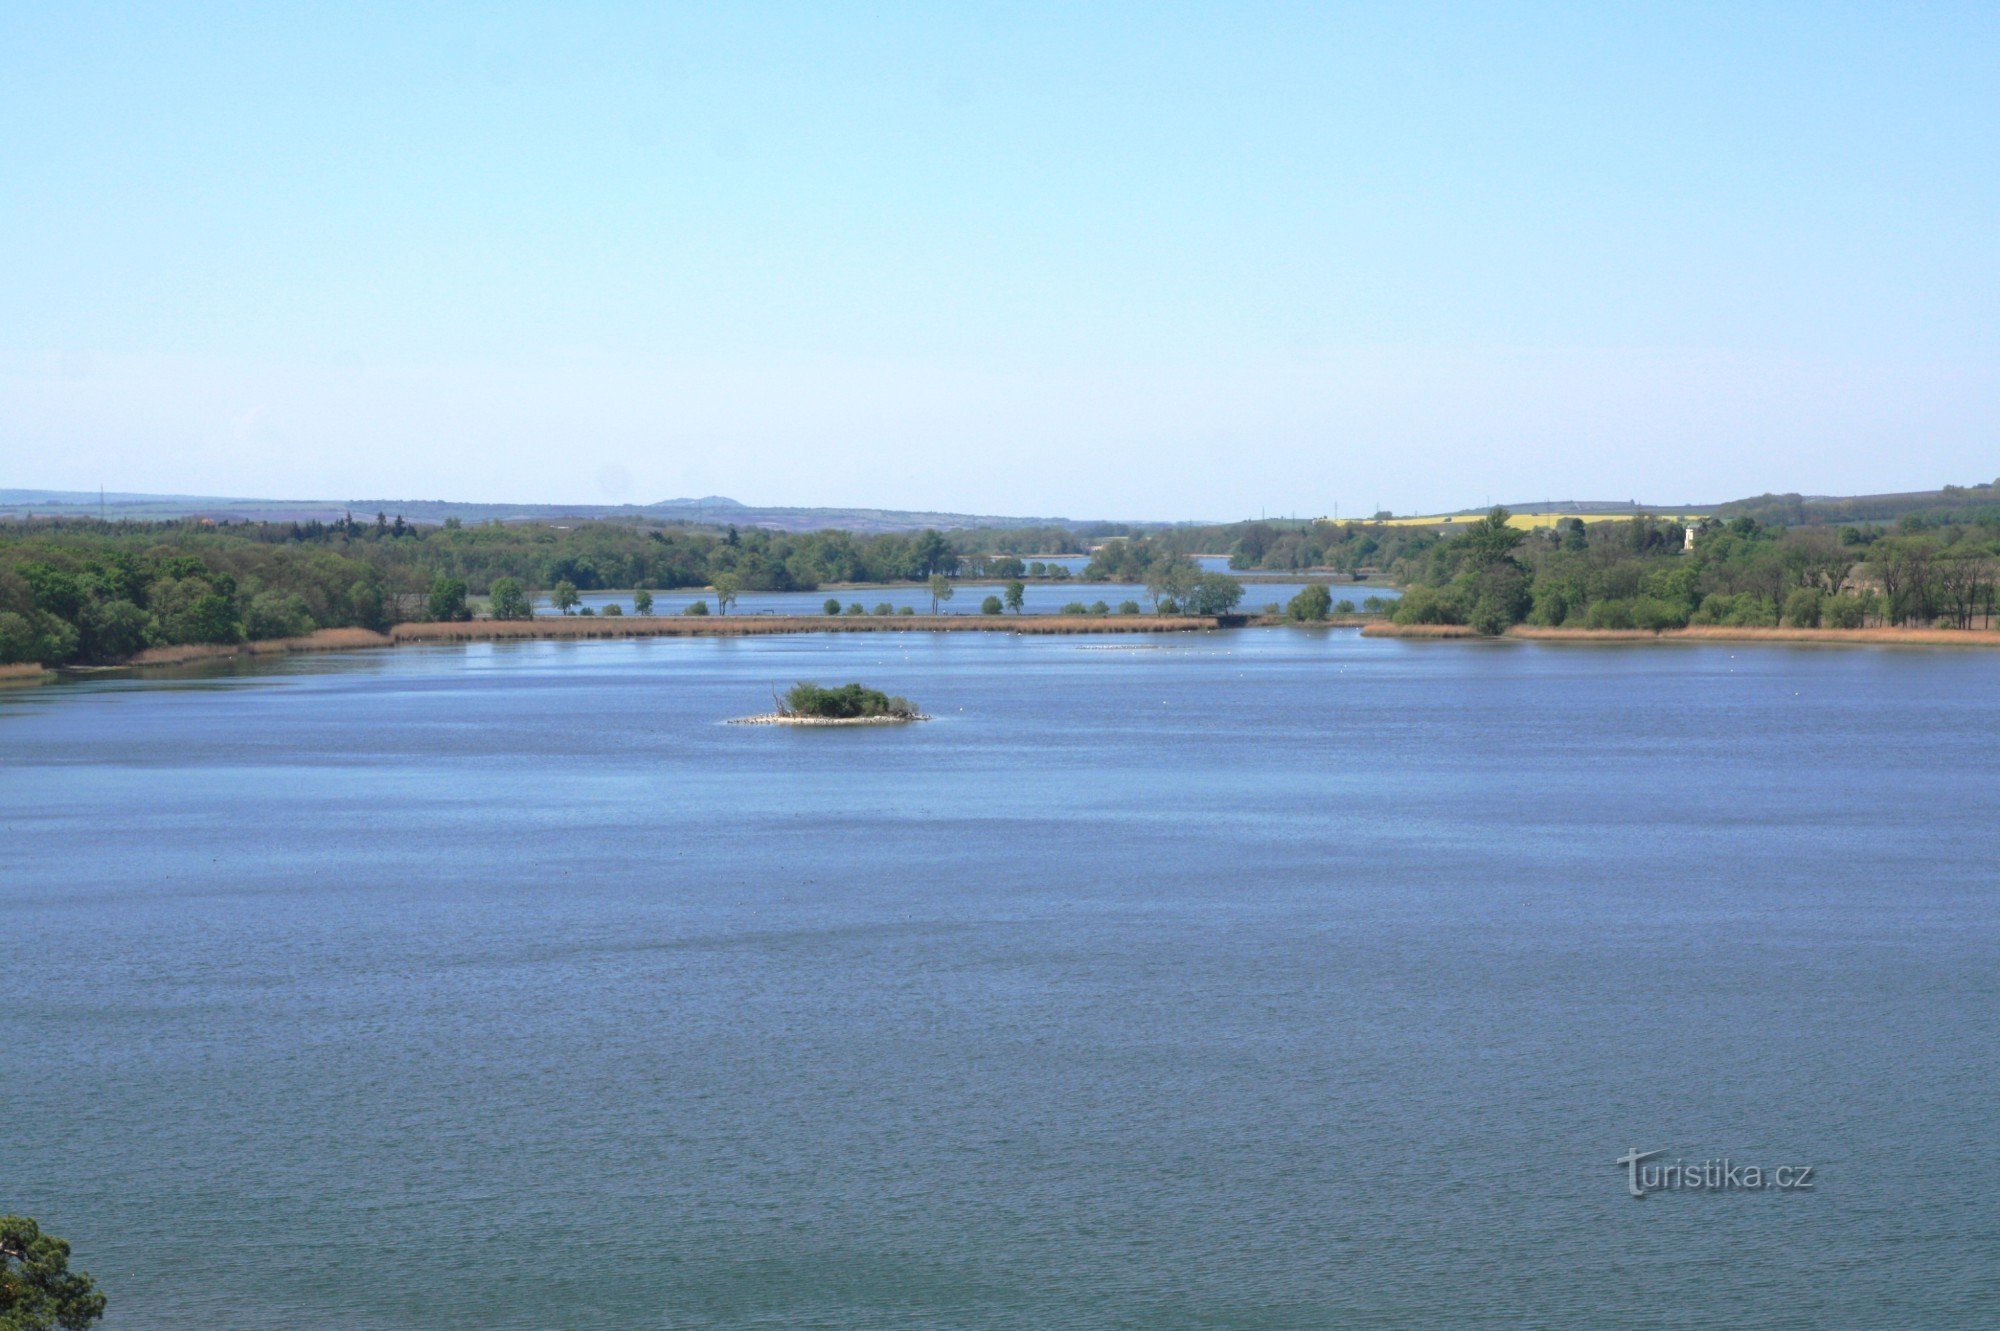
[0, 630, 2000, 1331]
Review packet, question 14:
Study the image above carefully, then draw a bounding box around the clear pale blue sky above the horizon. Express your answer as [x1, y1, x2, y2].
[0, 0, 2000, 520]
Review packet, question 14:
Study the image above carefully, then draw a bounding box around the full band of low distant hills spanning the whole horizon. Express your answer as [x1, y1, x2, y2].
[0, 482, 2000, 534]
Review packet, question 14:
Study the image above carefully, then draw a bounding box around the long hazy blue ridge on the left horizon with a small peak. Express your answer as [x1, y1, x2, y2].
[0, 490, 1078, 534]
